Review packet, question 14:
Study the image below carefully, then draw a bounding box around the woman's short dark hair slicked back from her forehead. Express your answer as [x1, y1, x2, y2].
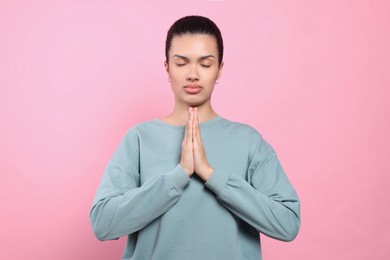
[165, 15, 223, 66]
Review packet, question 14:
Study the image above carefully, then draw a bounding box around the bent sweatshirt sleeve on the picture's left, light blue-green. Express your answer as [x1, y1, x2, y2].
[89, 127, 190, 240]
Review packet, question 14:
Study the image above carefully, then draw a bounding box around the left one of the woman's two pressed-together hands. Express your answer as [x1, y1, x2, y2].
[180, 107, 195, 177]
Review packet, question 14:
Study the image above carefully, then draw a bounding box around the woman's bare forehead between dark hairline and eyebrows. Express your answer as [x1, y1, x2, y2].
[170, 34, 218, 57]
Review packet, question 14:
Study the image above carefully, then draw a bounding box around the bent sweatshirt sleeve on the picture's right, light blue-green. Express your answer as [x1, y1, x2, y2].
[205, 131, 300, 241]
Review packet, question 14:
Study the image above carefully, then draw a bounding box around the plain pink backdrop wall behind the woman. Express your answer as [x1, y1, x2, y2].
[0, 0, 390, 260]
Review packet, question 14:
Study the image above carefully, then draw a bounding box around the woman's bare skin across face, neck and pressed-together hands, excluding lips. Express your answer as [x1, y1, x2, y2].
[161, 34, 224, 181]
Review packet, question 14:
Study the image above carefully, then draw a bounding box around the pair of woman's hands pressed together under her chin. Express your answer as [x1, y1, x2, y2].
[180, 107, 214, 181]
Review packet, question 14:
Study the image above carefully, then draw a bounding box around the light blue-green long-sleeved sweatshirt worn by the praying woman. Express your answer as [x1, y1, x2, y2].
[90, 116, 300, 260]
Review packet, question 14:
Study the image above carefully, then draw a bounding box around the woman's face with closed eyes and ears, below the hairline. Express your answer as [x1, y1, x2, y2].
[165, 34, 223, 106]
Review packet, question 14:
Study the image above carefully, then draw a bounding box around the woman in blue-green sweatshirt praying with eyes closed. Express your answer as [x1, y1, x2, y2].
[90, 16, 300, 260]
